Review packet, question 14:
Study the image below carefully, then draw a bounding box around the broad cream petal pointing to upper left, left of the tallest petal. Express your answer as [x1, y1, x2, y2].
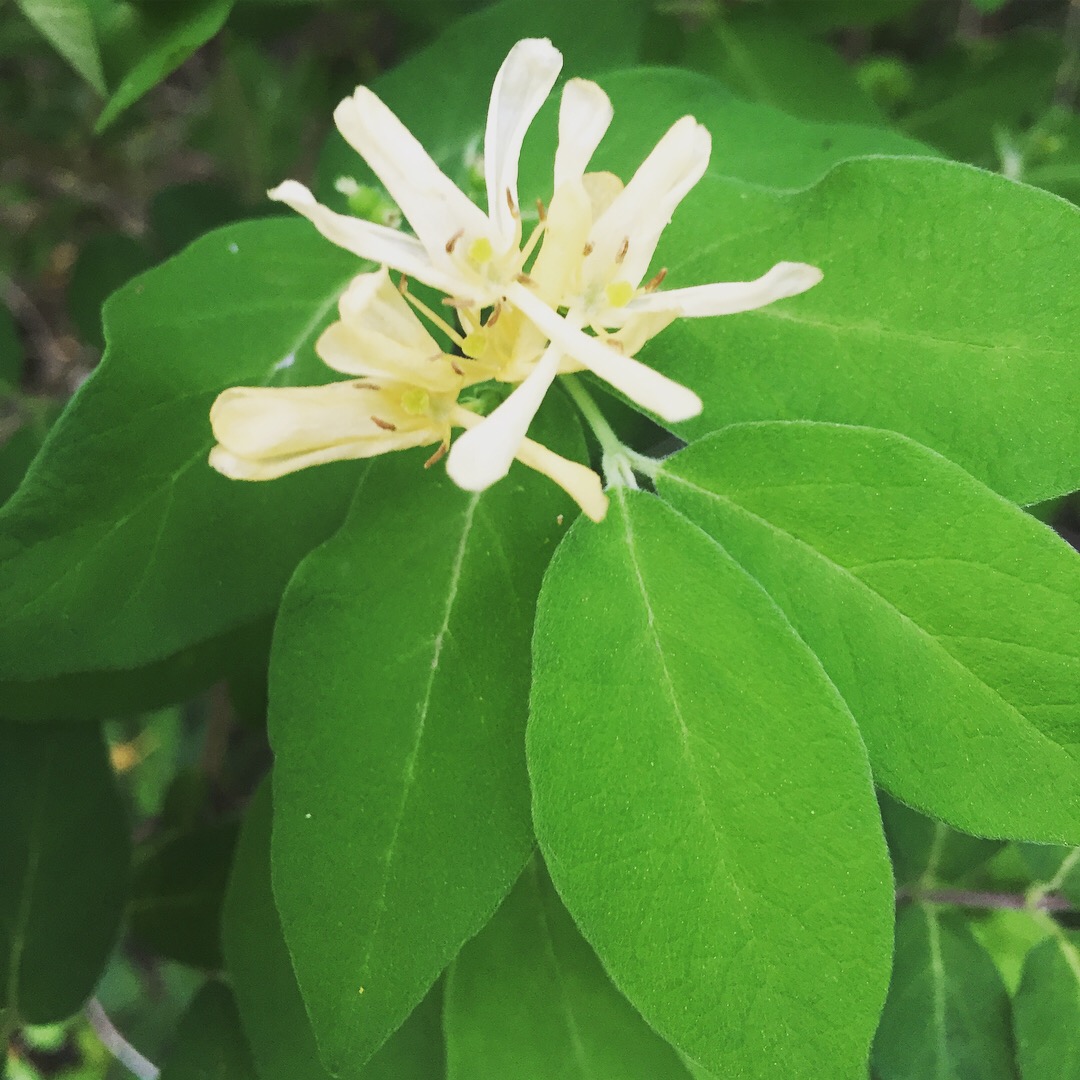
[334, 86, 490, 267]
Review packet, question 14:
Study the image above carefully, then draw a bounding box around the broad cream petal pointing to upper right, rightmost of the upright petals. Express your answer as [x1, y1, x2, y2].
[589, 117, 712, 285]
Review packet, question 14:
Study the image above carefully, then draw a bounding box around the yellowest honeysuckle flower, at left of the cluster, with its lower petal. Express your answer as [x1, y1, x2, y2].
[210, 269, 607, 521]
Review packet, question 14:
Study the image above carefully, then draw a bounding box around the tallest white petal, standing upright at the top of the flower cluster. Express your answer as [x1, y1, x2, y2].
[486, 38, 563, 252]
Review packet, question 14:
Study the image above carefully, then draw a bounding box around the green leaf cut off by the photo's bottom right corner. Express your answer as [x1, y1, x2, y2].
[1013, 930, 1080, 1080]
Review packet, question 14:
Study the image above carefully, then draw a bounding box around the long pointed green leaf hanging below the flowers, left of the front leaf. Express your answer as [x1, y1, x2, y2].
[270, 411, 580, 1072]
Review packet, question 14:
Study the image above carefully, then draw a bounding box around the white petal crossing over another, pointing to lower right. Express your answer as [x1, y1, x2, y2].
[507, 284, 701, 423]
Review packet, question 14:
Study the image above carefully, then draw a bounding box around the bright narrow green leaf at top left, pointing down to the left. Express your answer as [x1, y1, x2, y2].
[94, 0, 233, 134]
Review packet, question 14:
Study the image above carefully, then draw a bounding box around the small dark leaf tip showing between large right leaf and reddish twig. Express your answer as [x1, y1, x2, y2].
[878, 792, 1004, 888]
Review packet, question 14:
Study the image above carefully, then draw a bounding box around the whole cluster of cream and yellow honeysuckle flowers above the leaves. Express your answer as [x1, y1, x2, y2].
[211, 39, 821, 521]
